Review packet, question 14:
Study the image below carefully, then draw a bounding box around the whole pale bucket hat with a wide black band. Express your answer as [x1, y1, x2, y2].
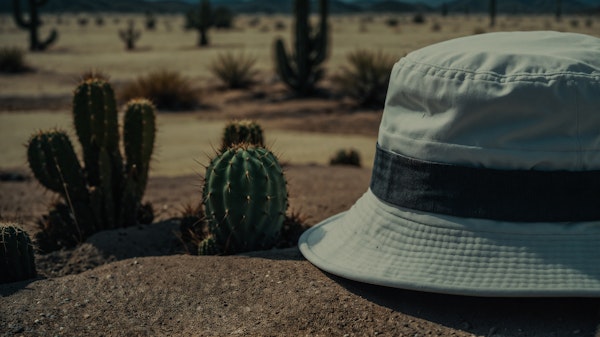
[299, 32, 600, 297]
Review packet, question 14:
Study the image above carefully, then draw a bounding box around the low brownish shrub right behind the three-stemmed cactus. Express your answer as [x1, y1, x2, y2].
[120, 70, 200, 111]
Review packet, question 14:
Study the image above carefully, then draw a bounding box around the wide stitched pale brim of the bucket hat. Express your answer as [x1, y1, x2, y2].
[298, 190, 600, 297]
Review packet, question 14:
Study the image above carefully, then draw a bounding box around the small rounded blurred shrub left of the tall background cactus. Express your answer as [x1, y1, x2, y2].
[209, 52, 257, 89]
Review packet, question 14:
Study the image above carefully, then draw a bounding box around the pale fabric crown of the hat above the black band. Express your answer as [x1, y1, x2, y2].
[378, 32, 600, 171]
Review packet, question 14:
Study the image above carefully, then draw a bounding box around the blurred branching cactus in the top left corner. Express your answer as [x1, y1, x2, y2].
[13, 0, 58, 51]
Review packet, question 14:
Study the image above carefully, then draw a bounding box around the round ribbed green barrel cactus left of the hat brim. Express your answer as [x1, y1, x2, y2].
[203, 144, 288, 254]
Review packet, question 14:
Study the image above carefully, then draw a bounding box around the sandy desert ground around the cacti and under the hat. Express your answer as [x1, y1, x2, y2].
[0, 14, 600, 337]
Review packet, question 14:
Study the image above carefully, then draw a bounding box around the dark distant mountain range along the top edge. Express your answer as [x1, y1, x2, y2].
[0, 0, 600, 14]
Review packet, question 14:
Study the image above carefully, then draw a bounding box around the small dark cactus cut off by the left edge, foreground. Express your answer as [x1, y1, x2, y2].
[0, 222, 36, 283]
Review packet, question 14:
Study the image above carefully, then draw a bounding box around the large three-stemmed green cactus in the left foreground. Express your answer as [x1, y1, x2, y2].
[27, 77, 156, 250]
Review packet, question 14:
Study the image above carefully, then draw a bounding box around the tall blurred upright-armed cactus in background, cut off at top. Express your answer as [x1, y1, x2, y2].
[275, 0, 328, 96]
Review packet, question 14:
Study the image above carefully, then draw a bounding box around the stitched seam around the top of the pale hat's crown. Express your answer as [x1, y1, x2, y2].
[404, 57, 600, 83]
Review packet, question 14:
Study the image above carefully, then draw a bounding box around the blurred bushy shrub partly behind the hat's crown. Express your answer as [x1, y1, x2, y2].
[332, 49, 396, 106]
